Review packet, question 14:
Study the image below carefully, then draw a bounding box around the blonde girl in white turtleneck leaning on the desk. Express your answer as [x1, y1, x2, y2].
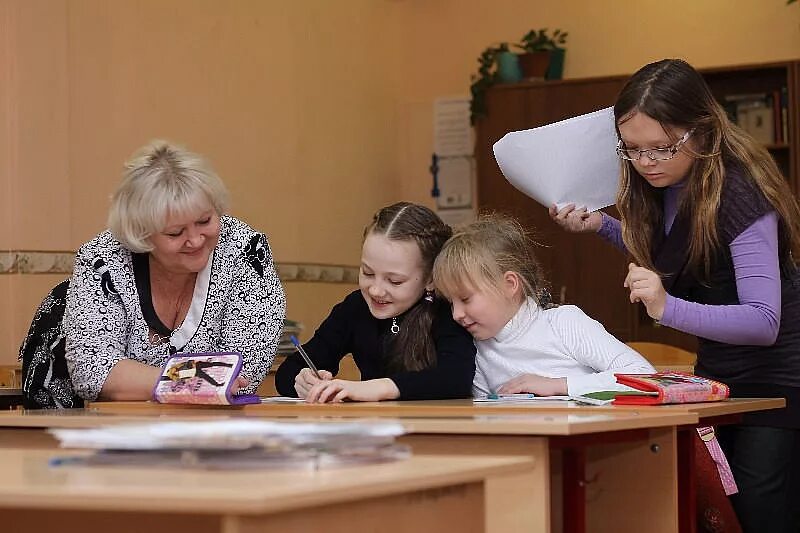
[433, 215, 655, 397]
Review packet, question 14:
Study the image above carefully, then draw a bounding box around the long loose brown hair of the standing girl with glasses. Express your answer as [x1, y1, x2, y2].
[614, 59, 800, 278]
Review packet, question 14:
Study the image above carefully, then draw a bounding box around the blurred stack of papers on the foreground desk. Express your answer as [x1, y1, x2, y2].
[49, 420, 410, 469]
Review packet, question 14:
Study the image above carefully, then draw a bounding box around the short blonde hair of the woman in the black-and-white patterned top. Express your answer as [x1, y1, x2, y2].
[108, 140, 228, 253]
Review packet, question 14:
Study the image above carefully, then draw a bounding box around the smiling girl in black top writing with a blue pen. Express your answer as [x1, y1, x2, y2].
[275, 202, 475, 403]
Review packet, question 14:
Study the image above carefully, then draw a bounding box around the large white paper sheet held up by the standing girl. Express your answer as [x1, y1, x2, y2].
[494, 107, 620, 211]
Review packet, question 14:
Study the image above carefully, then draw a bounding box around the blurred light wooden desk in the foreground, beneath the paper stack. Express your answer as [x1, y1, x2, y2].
[0, 449, 536, 533]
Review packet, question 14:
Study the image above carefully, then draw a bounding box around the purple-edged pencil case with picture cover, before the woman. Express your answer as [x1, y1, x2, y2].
[153, 352, 260, 405]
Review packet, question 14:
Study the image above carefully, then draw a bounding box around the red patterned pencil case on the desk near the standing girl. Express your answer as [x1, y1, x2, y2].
[613, 372, 730, 405]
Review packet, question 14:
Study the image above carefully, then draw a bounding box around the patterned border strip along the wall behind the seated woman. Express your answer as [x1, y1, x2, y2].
[0, 250, 358, 285]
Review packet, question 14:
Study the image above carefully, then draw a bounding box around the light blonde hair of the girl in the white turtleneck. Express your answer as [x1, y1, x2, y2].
[433, 213, 553, 308]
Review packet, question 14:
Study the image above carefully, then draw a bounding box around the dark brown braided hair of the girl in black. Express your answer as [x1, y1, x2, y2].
[364, 202, 453, 370]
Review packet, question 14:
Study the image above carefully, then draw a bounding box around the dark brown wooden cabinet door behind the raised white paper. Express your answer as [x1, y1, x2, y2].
[477, 78, 635, 340]
